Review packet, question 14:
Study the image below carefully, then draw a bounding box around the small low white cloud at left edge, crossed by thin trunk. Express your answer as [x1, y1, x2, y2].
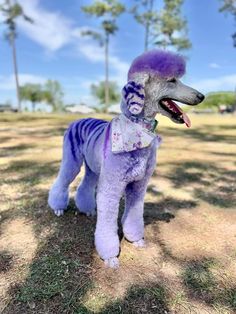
[0, 73, 47, 91]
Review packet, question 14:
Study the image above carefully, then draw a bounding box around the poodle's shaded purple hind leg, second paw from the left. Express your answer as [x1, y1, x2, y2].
[75, 165, 98, 216]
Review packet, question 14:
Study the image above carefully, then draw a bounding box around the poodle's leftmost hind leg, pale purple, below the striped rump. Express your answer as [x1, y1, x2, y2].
[48, 130, 83, 216]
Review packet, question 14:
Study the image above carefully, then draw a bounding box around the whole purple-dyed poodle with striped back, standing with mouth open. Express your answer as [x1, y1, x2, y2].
[48, 50, 204, 268]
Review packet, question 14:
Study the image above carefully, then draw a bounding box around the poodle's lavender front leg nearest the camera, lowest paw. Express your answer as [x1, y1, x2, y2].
[95, 177, 125, 268]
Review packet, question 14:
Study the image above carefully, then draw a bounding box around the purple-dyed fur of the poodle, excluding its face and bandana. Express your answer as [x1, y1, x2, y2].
[48, 50, 185, 267]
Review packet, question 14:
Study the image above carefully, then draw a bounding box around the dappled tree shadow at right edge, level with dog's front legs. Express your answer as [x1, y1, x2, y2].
[164, 161, 236, 208]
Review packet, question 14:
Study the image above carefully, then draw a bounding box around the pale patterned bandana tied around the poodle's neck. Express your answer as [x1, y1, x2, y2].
[111, 114, 160, 153]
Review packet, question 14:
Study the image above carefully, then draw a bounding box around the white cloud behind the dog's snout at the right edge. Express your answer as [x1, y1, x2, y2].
[191, 74, 236, 93]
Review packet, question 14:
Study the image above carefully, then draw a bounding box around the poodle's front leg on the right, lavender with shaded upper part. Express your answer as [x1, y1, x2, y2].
[121, 178, 148, 247]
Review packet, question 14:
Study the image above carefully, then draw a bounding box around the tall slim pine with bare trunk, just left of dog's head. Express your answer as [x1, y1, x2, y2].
[82, 0, 125, 106]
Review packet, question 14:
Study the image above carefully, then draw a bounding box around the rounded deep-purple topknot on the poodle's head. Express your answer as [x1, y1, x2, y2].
[128, 49, 185, 80]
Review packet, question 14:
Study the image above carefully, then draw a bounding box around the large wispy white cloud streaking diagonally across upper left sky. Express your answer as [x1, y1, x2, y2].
[15, 0, 129, 80]
